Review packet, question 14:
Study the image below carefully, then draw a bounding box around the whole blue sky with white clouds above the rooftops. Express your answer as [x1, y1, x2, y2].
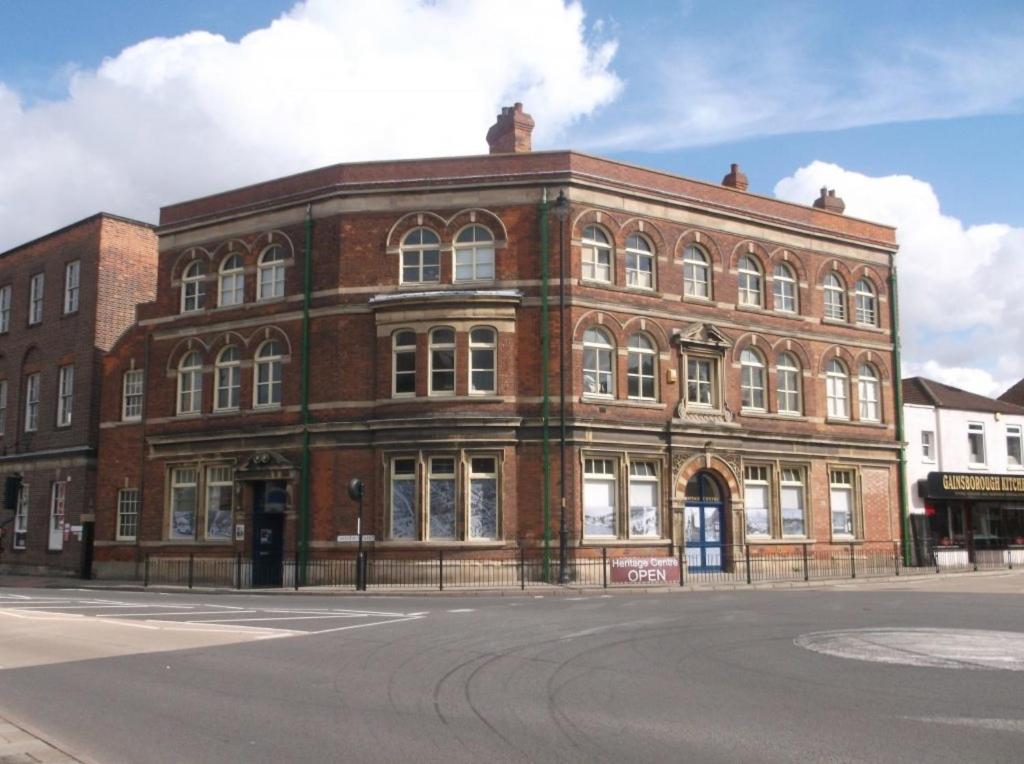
[0, 0, 1024, 393]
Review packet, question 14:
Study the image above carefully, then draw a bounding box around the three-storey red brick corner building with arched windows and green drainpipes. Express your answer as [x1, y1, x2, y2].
[96, 104, 899, 583]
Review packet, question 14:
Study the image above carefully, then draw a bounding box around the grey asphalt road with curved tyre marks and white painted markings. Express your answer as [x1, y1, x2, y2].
[0, 572, 1024, 764]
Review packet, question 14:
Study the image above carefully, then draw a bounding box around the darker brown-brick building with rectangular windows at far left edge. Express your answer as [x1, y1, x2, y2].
[0, 213, 157, 575]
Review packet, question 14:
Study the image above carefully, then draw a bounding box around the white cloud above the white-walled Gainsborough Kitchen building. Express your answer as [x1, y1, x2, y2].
[775, 162, 1024, 395]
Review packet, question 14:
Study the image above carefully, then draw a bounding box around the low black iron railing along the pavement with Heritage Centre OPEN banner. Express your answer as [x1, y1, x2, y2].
[142, 542, 1024, 591]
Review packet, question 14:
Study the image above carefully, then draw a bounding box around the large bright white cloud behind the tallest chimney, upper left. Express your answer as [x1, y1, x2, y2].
[0, 0, 622, 251]
